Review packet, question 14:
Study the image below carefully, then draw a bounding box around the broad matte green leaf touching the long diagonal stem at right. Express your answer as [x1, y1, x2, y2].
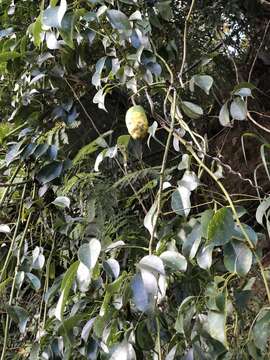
[207, 207, 234, 246]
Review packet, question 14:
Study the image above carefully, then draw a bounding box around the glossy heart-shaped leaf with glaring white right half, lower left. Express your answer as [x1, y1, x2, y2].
[78, 239, 101, 270]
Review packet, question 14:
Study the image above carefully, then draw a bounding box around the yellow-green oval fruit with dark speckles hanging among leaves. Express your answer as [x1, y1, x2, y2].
[126, 105, 148, 140]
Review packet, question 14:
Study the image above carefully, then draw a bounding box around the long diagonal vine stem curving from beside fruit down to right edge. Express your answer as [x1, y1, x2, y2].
[166, 126, 270, 304]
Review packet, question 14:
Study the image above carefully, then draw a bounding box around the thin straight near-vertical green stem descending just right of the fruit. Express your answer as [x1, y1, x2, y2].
[149, 89, 176, 255]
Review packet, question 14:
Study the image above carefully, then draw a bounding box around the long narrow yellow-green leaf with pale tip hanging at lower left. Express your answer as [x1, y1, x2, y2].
[54, 261, 79, 321]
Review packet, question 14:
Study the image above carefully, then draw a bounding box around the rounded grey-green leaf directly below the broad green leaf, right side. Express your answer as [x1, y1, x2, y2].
[224, 240, 252, 276]
